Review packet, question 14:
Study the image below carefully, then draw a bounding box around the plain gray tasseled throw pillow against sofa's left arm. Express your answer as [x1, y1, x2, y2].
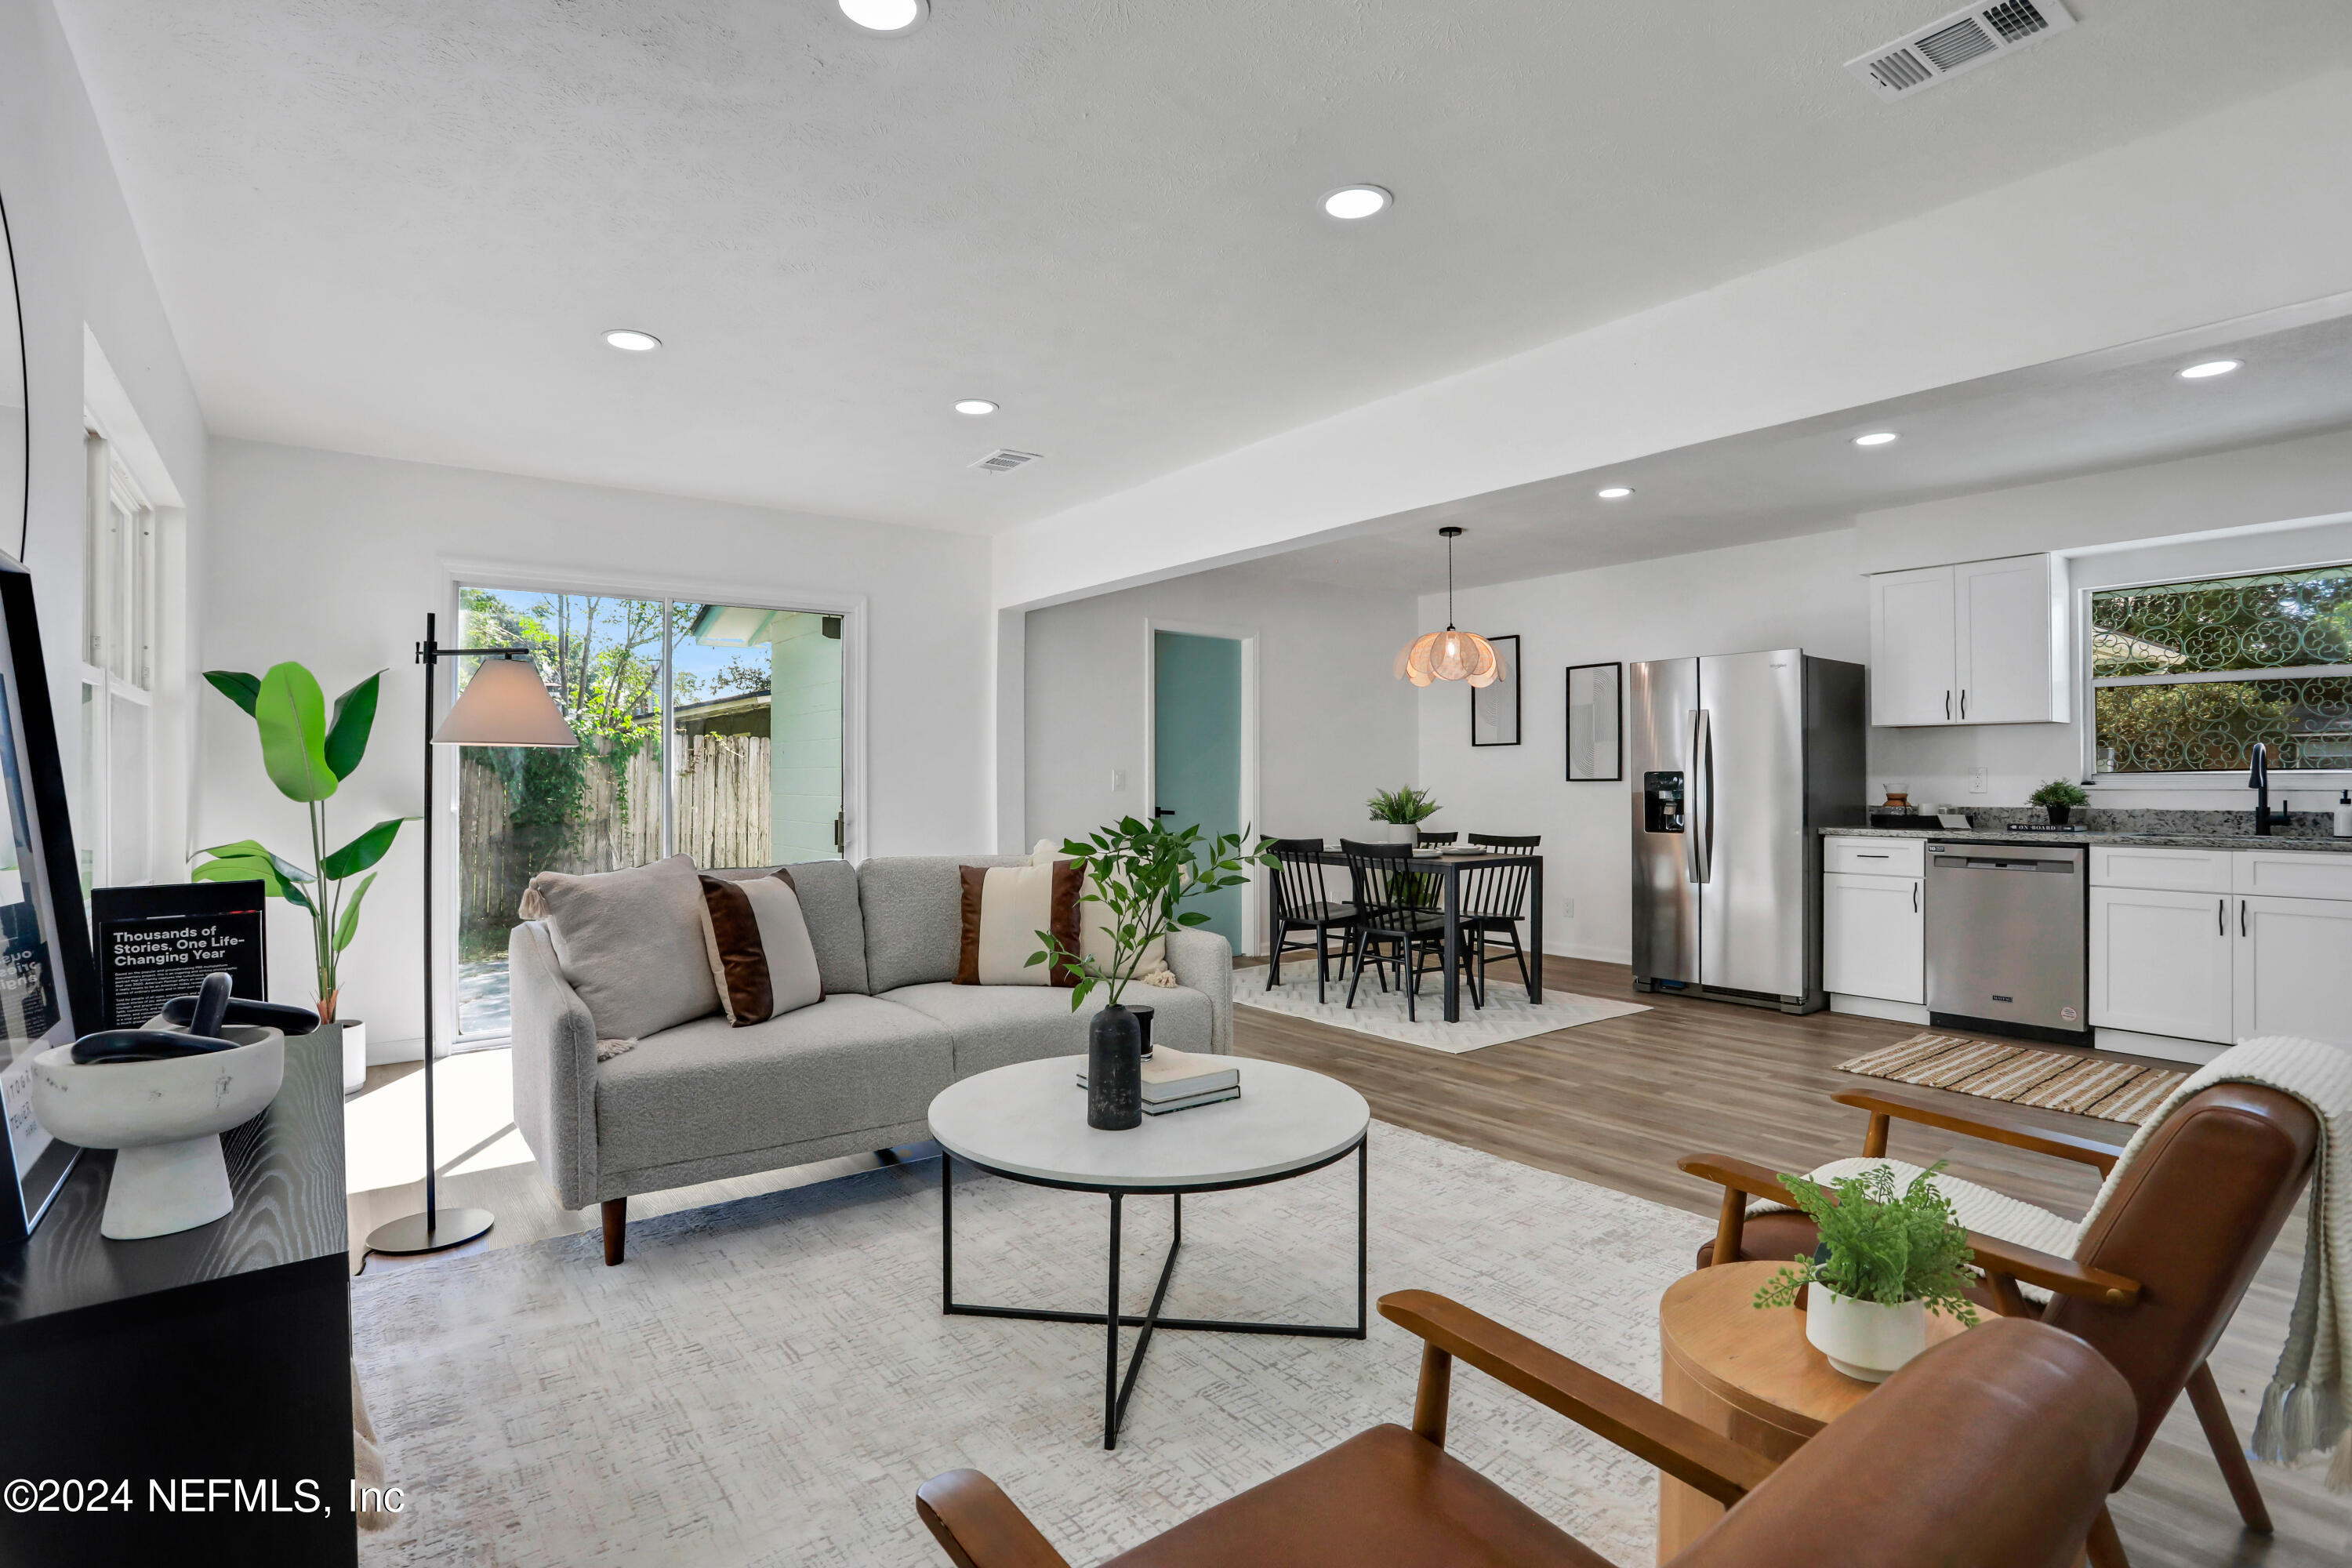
[522, 855, 720, 1039]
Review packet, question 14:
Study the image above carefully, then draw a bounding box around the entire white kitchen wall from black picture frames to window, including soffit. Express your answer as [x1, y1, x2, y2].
[1421, 435, 2352, 961]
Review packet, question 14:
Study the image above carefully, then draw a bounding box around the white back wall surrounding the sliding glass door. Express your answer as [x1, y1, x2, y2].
[198, 440, 993, 1060]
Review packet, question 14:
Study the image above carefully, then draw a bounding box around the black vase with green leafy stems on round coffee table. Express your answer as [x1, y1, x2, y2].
[1030, 815, 1272, 1131]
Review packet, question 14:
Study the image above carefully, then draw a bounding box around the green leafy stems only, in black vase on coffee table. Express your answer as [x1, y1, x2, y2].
[1028, 815, 1275, 1013]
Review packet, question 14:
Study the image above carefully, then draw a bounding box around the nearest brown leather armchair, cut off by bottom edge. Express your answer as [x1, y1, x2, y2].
[915, 1290, 2133, 1568]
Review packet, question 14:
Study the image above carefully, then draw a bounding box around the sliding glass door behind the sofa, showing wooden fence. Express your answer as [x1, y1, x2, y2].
[456, 586, 844, 1039]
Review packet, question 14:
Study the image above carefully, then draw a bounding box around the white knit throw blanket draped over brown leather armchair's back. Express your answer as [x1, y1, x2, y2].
[2082, 1034, 2352, 1493]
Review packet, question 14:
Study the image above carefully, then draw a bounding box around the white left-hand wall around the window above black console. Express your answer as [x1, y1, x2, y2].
[0, 0, 205, 921]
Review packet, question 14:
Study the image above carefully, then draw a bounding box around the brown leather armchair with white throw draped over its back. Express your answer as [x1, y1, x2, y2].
[1677, 1083, 2319, 1568]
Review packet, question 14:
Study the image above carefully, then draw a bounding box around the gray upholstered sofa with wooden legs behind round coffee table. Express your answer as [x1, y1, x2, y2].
[508, 855, 1232, 1262]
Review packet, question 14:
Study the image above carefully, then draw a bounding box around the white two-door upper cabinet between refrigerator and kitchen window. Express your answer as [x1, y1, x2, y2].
[1870, 555, 2072, 724]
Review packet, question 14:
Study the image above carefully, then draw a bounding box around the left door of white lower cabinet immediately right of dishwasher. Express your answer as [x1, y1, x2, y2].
[2091, 886, 2237, 1044]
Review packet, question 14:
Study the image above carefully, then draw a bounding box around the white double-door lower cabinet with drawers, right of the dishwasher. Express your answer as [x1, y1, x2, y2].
[2091, 848, 2352, 1046]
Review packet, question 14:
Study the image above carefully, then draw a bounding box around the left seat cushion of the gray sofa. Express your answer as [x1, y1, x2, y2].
[595, 992, 955, 1175]
